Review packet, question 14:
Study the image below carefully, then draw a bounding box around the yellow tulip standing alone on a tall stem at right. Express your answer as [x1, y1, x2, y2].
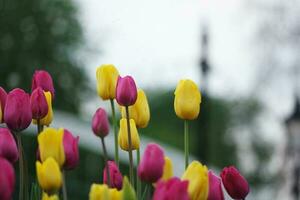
[174, 79, 201, 120]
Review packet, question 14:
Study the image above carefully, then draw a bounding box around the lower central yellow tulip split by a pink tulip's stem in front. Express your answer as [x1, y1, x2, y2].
[118, 118, 140, 151]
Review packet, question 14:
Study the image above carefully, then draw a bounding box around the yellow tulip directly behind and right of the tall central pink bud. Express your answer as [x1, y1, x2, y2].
[121, 89, 150, 128]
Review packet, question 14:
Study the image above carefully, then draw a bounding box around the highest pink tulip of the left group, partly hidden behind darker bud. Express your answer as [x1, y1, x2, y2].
[31, 70, 55, 98]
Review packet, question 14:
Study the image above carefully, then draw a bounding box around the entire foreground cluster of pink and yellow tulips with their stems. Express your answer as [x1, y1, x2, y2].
[0, 64, 250, 200]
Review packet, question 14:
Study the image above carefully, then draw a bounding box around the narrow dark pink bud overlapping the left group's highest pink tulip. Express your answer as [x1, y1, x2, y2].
[30, 87, 48, 119]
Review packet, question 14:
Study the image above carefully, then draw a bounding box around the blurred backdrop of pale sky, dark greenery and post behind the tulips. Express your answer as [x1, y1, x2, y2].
[0, 0, 300, 200]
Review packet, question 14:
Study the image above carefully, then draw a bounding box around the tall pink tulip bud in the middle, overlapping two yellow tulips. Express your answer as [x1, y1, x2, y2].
[116, 76, 137, 106]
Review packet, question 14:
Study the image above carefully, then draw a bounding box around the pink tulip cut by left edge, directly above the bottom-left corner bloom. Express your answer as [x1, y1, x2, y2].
[0, 128, 19, 163]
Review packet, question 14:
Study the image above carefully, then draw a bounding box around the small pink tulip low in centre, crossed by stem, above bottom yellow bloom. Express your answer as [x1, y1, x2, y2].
[103, 161, 123, 190]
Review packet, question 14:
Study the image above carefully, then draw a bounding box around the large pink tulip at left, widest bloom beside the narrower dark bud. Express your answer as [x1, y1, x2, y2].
[4, 88, 32, 132]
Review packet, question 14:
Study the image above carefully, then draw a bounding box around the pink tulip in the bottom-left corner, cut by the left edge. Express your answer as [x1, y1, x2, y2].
[0, 157, 15, 200]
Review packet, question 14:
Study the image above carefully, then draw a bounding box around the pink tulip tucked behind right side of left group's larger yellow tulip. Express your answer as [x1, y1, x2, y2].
[63, 129, 79, 170]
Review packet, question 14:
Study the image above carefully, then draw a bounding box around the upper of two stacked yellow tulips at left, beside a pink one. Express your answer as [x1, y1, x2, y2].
[38, 128, 65, 167]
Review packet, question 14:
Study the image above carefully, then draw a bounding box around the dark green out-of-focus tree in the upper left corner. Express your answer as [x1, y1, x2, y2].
[0, 0, 88, 113]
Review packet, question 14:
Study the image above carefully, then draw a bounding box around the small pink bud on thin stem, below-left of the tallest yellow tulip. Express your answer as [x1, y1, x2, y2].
[92, 108, 109, 137]
